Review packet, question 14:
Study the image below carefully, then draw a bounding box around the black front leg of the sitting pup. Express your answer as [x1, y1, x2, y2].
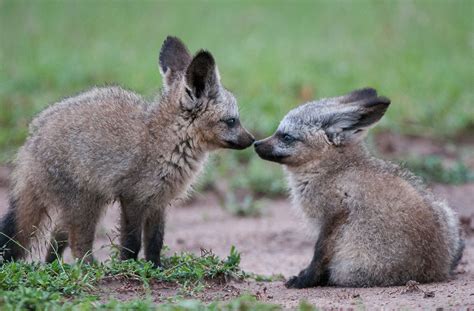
[285, 236, 329, 288]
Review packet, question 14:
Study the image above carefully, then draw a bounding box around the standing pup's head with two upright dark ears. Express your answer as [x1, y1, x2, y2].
[159, 37, 255, 150]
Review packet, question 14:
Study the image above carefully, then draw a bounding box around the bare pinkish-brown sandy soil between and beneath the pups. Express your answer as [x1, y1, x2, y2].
[0, 184, 474, 309]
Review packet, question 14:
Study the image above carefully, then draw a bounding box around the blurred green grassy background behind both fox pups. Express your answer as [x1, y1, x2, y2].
[0, 0, 474, 204]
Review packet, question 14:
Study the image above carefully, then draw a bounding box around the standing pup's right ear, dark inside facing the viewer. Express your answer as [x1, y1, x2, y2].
[186, 51, 220, 98]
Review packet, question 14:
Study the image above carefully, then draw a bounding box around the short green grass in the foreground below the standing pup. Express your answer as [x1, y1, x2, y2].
[0, 247, 315, 311]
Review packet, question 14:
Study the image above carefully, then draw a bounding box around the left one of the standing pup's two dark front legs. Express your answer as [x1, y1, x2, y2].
[120, 197, 143, 260]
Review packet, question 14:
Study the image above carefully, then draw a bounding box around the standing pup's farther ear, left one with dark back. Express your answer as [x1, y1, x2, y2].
[159, 36, 191, 88]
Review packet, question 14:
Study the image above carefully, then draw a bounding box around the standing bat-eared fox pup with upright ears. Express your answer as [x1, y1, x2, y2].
[0, 37, 254, 266]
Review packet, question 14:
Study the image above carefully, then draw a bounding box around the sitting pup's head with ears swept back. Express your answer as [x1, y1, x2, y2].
[255, 88, 390, 167]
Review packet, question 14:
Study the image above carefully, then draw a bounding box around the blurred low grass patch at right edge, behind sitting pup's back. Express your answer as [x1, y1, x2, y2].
[404, 156, 474, 184]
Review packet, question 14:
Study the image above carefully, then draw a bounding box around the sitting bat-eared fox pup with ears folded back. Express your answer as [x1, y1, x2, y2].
[255, 88, 463, 288]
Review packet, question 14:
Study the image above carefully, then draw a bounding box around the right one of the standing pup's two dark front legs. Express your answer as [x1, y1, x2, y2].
[144, 206, 165, 267]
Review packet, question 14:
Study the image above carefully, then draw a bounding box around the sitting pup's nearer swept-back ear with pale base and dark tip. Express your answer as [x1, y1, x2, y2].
[322, 97, 390, 146]
